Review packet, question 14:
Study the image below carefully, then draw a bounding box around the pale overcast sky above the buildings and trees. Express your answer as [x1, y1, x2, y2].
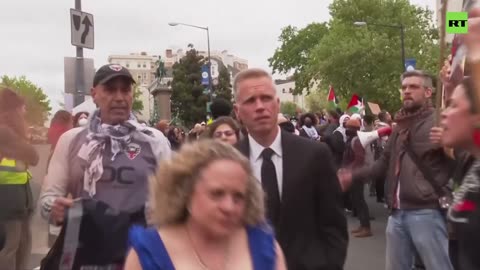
[0, 0, 435, 112]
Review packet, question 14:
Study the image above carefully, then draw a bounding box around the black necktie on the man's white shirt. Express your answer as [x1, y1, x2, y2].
[261, 148, 280, 227]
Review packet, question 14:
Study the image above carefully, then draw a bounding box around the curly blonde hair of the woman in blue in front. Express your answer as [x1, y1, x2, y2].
[149, 139, 266, 226]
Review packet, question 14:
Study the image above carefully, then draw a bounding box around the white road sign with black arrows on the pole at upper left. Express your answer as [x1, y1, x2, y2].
[70, 8, 94, 49]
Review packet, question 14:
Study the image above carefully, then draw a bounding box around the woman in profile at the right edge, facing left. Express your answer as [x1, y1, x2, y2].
[431, 78, 480, 270]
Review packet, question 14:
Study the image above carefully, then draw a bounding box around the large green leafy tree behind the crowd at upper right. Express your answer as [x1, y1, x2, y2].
[273, 0, 439, 111]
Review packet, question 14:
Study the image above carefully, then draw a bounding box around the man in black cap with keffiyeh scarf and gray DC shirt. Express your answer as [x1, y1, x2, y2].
[40, 64, 171, 268]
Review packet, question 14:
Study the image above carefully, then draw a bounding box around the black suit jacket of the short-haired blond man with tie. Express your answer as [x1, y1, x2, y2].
[237, 131, 348, 270]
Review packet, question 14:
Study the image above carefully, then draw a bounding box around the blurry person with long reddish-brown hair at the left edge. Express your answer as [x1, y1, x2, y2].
[0, 89, 38, 270]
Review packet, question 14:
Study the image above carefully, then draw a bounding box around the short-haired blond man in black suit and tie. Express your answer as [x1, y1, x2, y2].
[233, 69, 348, 270]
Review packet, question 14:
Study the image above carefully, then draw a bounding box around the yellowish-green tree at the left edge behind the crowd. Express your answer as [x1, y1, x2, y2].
[0, 75, 52, 126]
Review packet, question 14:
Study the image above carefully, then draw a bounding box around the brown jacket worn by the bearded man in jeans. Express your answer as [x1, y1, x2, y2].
[354, 110, 452, 209]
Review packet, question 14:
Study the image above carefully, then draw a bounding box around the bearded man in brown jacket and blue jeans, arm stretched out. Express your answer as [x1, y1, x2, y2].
[339, 71, 453, 270]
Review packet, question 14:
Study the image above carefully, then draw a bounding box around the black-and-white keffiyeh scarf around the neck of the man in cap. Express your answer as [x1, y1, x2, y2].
[78, 110, 153, 197]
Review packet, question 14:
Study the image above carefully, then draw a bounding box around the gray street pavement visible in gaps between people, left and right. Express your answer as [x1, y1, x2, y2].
[24, 145, 387, 270]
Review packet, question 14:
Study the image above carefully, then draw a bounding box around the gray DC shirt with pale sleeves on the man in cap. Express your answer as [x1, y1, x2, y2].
[40, 127, 171, 223]
